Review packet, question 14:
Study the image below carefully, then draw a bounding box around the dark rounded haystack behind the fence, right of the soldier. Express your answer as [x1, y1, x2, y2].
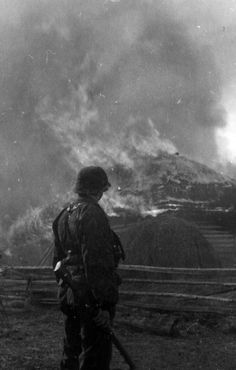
[120, 215, 221, 268]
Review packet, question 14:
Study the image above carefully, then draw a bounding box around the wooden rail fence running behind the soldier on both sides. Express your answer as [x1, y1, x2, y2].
[0, 265, 236, 315]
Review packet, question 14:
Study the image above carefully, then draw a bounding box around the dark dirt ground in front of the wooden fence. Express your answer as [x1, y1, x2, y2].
[0, 308, 236, 370]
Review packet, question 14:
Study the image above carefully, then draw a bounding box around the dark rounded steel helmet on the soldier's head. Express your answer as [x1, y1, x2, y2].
[75, 166, 111, 194]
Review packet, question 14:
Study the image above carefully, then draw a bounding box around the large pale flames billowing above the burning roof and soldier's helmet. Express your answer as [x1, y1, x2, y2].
[38, 85, 176, 169]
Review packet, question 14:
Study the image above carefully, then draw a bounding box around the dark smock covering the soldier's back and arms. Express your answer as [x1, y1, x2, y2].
[53, 198, 120, 305]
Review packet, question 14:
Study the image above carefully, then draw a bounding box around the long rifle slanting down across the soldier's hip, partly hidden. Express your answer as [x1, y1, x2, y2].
[54, 261, 136, 370]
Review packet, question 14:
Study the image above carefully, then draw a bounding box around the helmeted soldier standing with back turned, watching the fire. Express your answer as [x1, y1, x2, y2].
[53, 166, 124, 370]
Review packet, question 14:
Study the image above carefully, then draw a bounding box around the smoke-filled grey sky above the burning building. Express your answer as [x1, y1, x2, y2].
[0, 0, 236, 218]
